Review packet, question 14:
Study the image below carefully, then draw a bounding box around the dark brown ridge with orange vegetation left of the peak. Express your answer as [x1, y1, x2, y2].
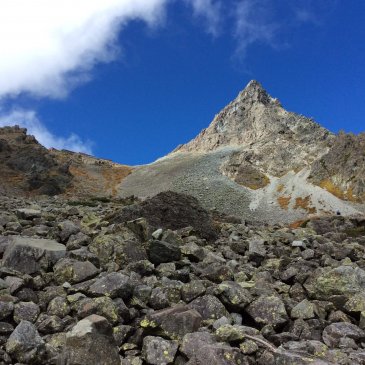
[0, 126, 132, 199]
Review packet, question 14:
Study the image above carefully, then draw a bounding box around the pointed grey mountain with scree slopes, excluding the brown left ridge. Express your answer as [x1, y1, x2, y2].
[120, 81, 365, 221]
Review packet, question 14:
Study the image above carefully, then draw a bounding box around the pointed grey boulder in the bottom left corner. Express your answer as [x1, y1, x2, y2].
[6, 321, 45, 364]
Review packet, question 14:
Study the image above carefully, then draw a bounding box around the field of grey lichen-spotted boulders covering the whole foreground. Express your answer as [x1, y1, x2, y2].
[0, 192, 365, 365]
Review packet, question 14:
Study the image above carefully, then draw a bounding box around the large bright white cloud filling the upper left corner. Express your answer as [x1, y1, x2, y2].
[0, 0, 169, 97]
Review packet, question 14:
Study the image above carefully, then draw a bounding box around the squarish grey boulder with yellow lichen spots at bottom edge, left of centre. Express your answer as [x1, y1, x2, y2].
[142, 336, 178, 365]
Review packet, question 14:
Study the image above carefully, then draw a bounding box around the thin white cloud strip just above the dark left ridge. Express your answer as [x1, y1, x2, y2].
[0, 110, 92, 154]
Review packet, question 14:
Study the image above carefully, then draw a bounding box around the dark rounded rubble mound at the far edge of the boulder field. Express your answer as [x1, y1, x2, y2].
[111, 191, 217, 240]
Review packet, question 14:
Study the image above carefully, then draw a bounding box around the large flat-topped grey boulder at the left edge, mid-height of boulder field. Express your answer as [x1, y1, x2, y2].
[2, 236, 66, 274]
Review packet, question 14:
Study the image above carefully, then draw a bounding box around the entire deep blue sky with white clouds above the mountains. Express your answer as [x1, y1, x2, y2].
[0, 0, 365, 165]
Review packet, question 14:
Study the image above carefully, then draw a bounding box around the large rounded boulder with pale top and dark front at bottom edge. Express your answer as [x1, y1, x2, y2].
[57, 315, 121, 365]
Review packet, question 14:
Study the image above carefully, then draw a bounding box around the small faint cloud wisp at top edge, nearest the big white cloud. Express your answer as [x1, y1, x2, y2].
[186, 0, 223, 36]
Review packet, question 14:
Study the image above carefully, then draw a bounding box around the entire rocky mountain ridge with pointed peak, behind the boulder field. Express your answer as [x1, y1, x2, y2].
[0, 81, 365, 223]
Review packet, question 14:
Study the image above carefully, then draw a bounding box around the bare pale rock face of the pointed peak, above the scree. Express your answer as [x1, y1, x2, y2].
[176, 81, 334, 189]
